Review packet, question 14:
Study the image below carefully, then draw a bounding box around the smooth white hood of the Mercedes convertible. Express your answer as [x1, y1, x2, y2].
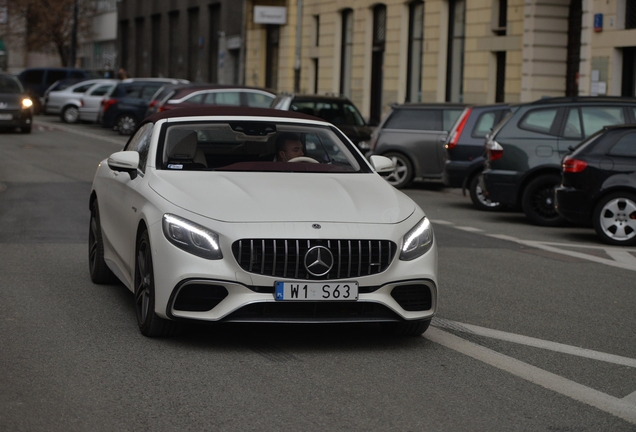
[149, 171, 415, 223]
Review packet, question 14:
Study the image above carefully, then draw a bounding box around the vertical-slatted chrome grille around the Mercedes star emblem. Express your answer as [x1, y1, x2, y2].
[232, 239, 397, 280]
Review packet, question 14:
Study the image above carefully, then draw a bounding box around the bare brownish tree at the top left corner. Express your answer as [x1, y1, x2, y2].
[6, 0, 96, 65]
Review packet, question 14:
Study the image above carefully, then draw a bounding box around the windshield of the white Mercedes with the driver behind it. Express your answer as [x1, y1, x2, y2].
[157, 121, 371, 173]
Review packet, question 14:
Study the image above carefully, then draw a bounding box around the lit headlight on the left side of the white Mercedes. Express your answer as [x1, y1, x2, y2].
[162, 214, 223, 259]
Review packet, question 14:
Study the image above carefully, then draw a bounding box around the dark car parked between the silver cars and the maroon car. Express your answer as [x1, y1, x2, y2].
[97, 80, 165, 135]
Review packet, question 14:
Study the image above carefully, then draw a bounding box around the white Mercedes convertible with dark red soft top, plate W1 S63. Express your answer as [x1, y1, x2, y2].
[88, 107, 437, 336]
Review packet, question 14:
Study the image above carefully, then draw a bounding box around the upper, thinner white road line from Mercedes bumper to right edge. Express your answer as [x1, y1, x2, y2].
[436, 318, 636, 368]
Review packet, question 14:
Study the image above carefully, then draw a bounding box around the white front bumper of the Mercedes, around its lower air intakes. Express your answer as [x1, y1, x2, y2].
[150, 219, 438, 323]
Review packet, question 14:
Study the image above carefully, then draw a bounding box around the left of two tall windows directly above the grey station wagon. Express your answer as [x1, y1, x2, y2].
[406, 0, 424, 102]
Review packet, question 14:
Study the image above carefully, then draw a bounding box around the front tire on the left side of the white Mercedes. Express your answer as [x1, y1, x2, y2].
[135, 231, 181, 337]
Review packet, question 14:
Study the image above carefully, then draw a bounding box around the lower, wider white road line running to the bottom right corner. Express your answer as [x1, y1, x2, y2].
[424, 327, 636, 424]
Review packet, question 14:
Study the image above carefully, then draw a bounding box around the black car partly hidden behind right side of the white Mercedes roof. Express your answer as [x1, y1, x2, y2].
[271, 93, 374, 153]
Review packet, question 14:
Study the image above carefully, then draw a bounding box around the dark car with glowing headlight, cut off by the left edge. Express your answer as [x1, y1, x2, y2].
[0, 73, 33, 133]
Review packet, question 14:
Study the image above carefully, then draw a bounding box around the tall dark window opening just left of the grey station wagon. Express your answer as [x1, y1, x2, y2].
[370, 5, 386, 124]
